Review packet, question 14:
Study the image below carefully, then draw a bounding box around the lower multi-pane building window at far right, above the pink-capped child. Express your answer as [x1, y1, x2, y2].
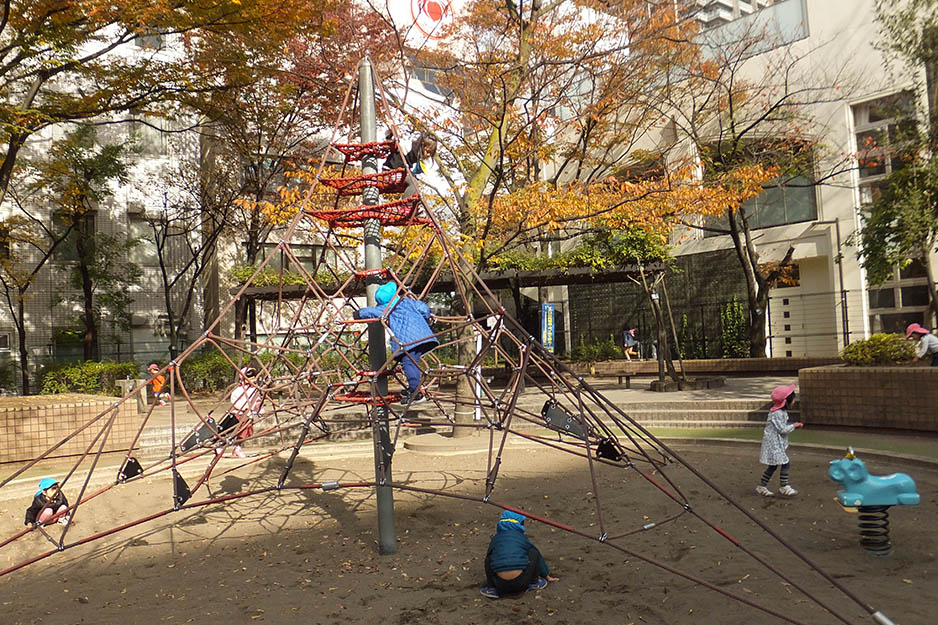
[868, 260, 928, 334]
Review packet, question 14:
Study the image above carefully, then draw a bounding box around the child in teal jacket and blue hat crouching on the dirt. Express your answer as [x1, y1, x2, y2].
[482, 510, 559, 599]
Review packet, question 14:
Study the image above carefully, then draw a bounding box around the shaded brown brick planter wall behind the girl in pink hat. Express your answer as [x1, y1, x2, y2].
[798, 365, 938, 432]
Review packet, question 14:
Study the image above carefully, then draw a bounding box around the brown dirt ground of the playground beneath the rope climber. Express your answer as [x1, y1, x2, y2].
[0, 446, 938, 625]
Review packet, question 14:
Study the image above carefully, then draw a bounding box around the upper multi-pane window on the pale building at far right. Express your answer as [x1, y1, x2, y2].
[852, 91, 915, 205]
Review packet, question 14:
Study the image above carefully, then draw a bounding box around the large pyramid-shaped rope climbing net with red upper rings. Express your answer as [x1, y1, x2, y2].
[0, 58, 891, 625]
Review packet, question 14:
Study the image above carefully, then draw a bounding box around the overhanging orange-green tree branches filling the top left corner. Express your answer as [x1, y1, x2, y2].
[0, 0, 330, 203]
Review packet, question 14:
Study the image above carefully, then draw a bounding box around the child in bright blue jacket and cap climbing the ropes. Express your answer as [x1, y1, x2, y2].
[352, 282, 440, 406]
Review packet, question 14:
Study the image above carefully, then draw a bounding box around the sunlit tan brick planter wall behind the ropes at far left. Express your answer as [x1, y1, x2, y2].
[0, 394, 140, 462]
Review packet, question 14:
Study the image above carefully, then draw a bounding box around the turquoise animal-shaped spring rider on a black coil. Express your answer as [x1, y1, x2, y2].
[827, 447, 919, 556]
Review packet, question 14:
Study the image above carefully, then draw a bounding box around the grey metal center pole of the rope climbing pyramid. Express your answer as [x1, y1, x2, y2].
[358, 57, 397, 555]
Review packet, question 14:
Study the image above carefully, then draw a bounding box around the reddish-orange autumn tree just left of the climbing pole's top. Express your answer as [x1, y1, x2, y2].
[187, 3, 397, 336]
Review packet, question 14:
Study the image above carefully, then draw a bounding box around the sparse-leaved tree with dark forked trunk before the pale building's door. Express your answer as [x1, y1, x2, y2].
[650, 21, 850, 357]
